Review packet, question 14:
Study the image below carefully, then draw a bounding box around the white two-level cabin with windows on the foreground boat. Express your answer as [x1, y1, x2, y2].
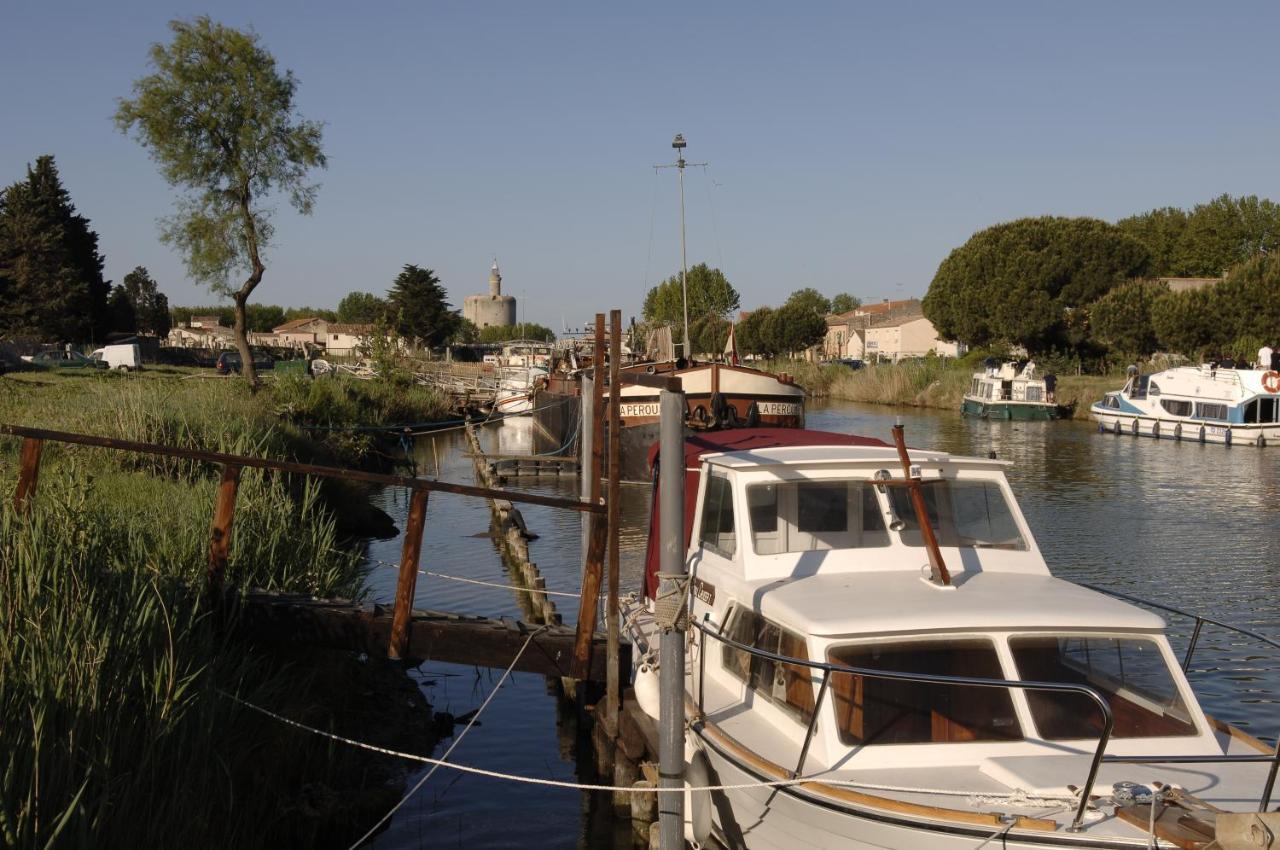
[646, 429, 1222, 778]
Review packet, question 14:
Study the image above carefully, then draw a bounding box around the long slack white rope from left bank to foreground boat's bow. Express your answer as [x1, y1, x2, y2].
[221, 691, 1073, 805]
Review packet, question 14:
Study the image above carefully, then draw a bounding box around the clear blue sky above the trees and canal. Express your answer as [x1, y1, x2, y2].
[0, 0, 1280, 330]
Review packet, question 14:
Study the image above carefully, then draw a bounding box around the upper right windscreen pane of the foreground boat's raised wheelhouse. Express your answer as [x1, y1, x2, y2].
[888, 481, 1027, 552]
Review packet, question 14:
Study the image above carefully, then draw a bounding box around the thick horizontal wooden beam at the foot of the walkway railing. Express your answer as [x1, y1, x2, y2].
[234, 593, 631, 681]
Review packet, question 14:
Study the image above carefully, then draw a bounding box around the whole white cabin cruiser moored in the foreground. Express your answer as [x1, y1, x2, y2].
[626, 429, 1280, 850]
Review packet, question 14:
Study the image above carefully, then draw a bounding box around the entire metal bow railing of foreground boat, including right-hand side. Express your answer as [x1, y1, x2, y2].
[691, 611, 1280, 832]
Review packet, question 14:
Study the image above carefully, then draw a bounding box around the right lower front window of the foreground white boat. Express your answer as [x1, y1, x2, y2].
[1009, 635, 1196, 740]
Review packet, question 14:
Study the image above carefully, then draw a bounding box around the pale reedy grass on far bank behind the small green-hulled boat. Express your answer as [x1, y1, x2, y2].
[764, 357, 1124, 420]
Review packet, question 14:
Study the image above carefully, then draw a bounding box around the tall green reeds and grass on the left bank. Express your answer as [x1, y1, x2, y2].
[0, 373, 442, 847]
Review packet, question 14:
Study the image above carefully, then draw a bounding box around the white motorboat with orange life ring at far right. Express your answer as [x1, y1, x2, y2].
[1089, 365, 1280, 447]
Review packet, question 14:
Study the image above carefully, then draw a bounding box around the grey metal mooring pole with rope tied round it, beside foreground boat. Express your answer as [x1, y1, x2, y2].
[658, 390, 685, 850]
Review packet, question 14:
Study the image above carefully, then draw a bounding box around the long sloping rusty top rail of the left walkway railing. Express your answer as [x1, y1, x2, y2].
[0, 425, 604, 513]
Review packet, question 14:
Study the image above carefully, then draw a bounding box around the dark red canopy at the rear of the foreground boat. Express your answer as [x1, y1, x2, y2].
[644, 428, 888, 599]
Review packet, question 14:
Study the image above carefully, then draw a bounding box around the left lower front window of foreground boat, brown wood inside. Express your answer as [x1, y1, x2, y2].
[828, 640, 1023, 744]
